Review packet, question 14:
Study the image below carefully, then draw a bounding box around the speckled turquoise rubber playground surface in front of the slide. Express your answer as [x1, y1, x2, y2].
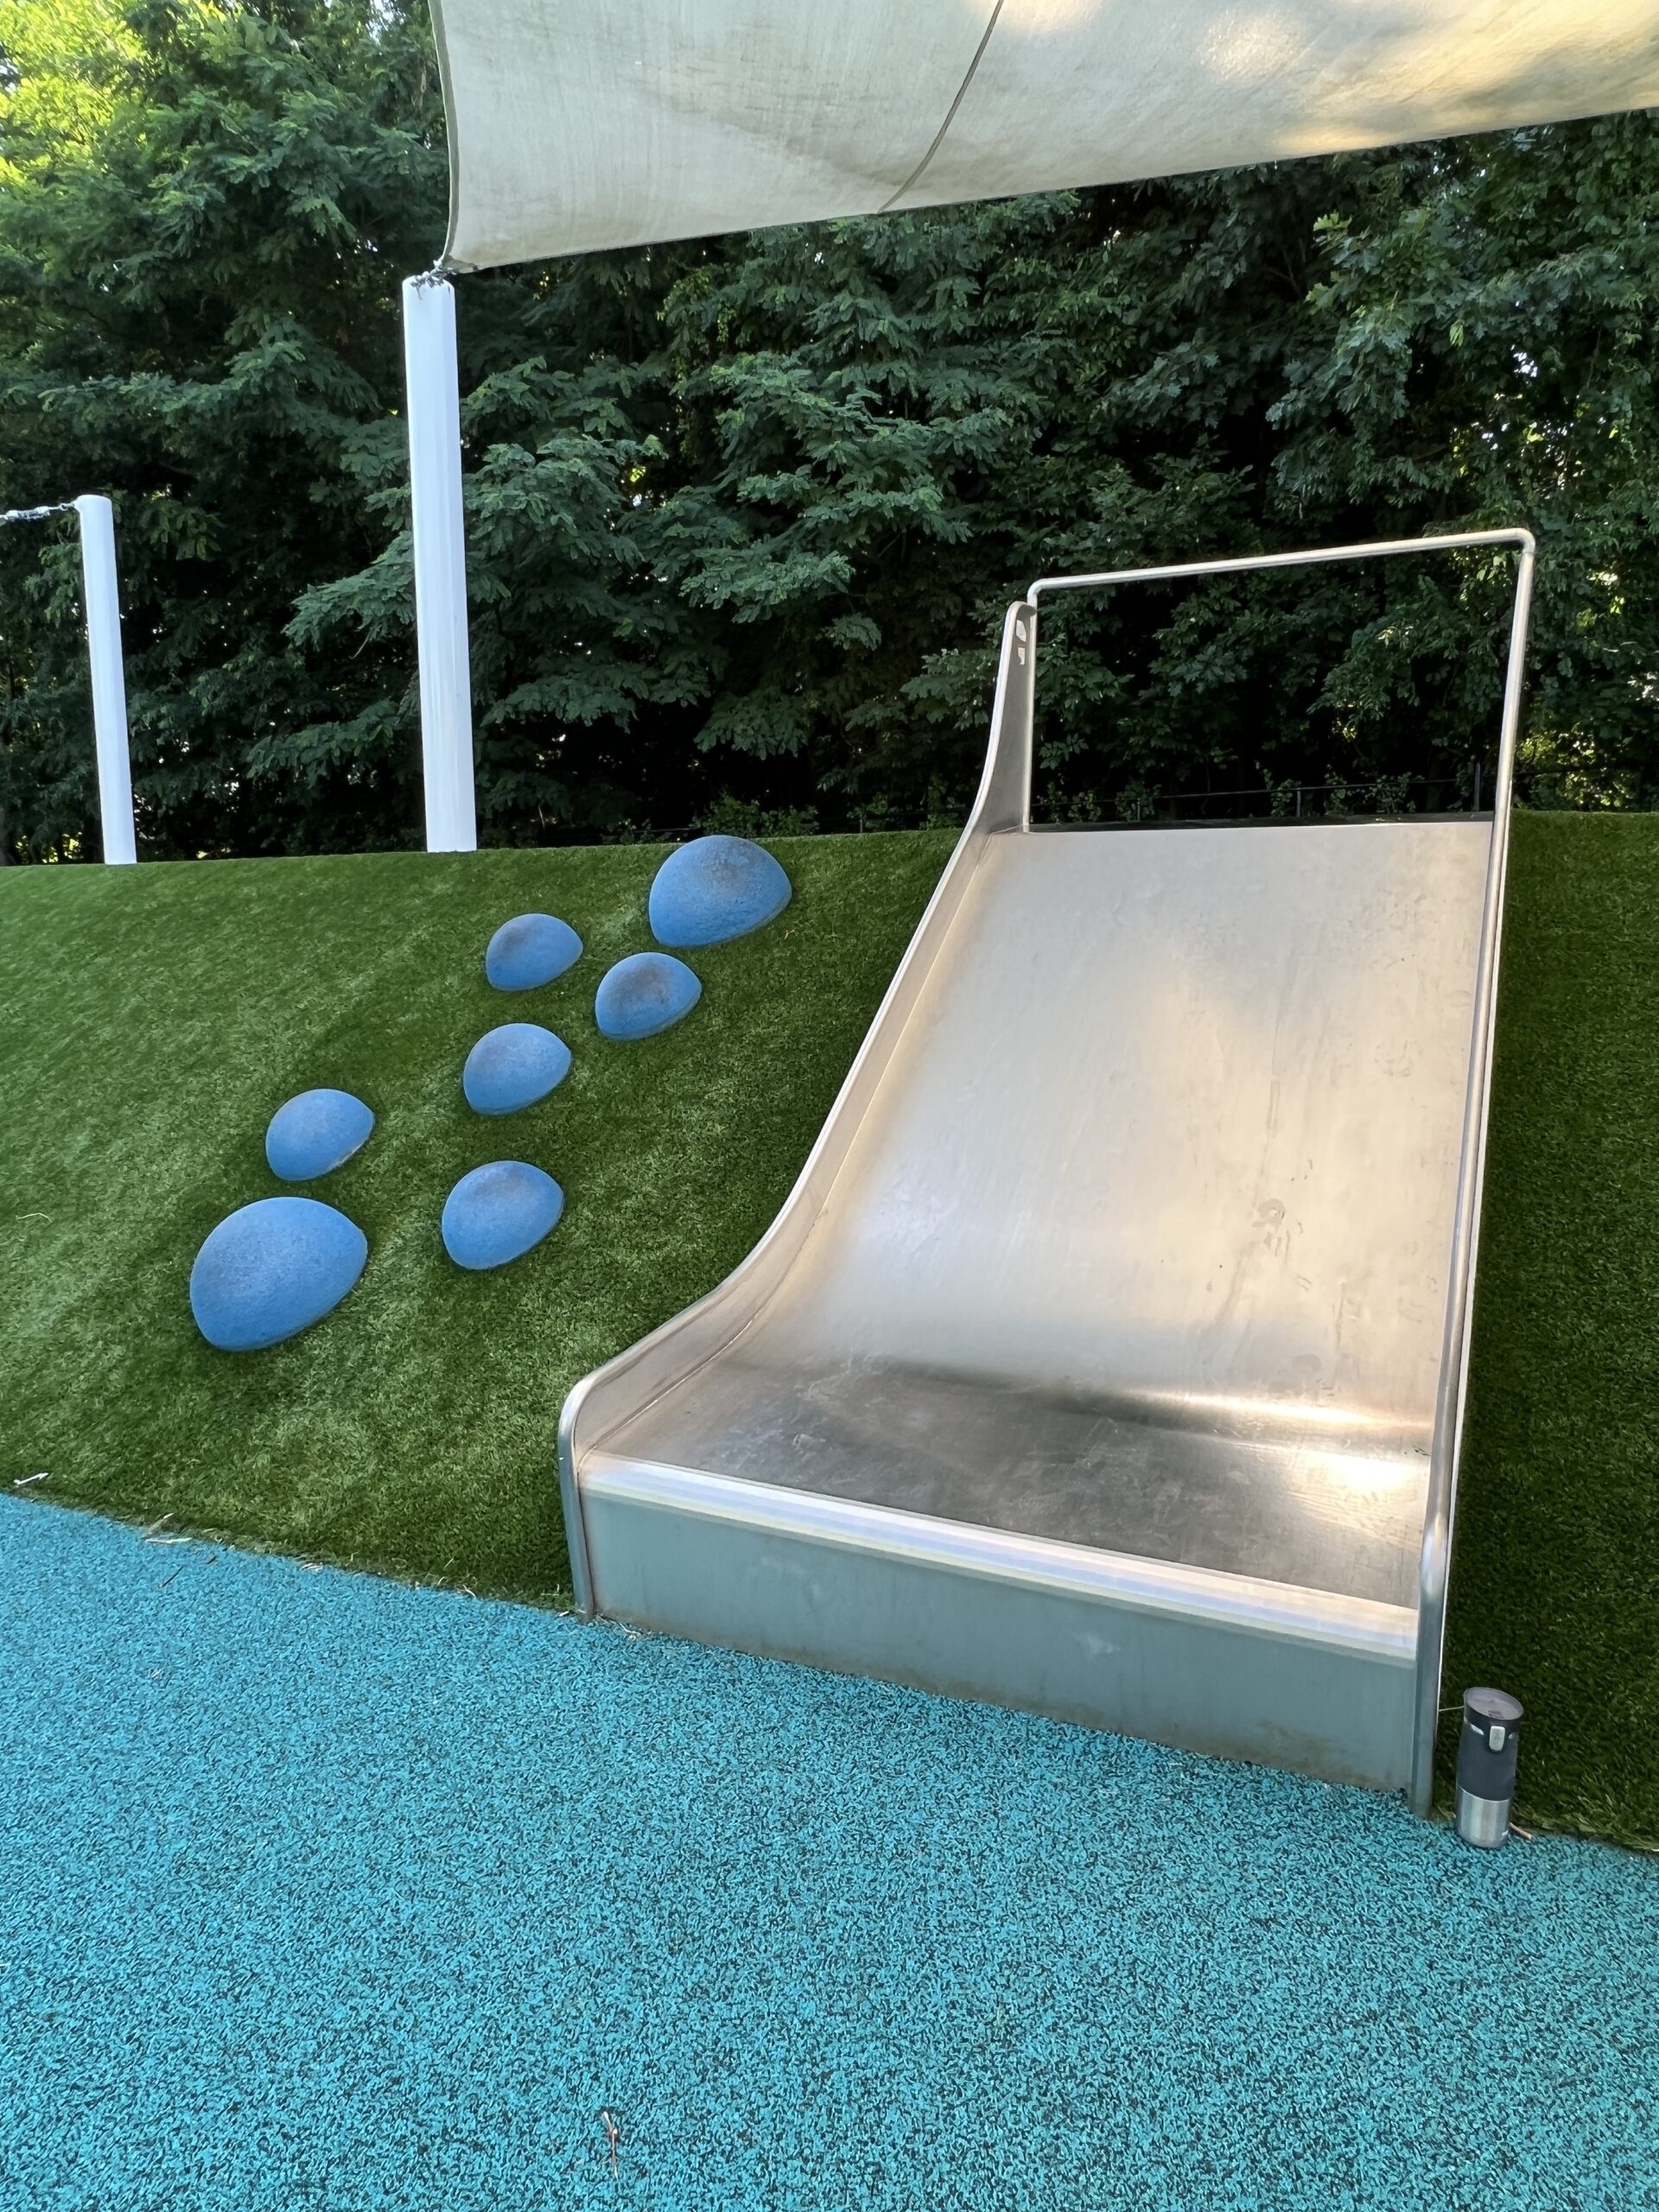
[0, 1500, 1659, 2212]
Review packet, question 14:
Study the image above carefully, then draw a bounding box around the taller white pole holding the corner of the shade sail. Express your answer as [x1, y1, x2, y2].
[403, 274, 478, 852]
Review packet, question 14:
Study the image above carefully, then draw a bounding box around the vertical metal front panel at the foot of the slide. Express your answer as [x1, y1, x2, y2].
[580, 1451, 1415, 1789]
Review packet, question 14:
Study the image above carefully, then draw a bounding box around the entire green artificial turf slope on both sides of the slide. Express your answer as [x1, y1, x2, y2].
[0, 817, 1659, 1840]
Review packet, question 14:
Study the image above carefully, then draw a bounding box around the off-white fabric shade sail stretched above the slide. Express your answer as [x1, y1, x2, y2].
[434, 0, 1659, 268]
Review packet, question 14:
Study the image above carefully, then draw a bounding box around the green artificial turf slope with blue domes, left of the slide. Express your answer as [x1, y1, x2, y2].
[0, 834, 951, 1599]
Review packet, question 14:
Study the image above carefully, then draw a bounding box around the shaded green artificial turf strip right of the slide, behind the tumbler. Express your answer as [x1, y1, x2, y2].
[1442, 814, 1659, 1845]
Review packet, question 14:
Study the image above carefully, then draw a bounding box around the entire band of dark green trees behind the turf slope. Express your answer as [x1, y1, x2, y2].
[0, 0, 1659, 858]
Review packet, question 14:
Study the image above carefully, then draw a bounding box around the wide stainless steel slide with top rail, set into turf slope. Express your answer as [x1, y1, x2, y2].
[560, 531, 1533, 1809]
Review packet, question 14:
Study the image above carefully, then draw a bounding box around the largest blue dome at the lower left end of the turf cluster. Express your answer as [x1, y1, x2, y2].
[190, 1197, 370, 1351]
